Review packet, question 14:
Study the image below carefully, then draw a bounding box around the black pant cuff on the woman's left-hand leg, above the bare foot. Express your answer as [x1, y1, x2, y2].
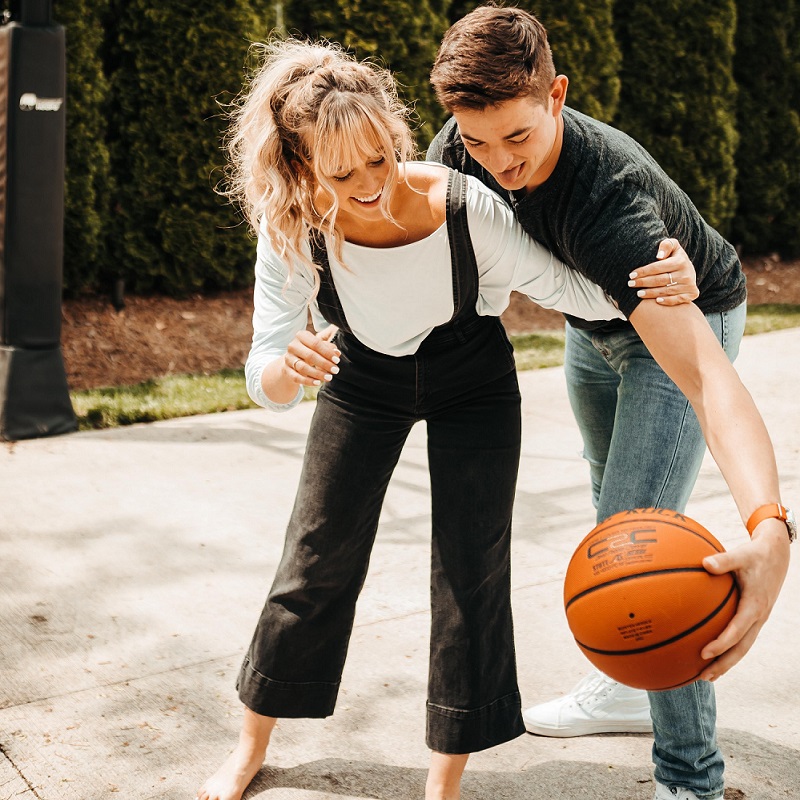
[236, 658, 339, 719]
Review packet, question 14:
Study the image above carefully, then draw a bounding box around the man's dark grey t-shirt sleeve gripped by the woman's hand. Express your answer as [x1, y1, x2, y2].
[572, 180, 671, 319]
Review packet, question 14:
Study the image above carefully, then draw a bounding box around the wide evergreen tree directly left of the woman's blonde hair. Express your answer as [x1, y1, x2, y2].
[104, 0, 273, 294]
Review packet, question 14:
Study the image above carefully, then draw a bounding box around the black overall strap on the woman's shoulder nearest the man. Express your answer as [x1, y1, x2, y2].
[447, 170, 478, 336]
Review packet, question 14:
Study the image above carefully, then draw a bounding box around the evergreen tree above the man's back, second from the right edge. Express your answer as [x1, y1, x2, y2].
[615, 0, 738, 234]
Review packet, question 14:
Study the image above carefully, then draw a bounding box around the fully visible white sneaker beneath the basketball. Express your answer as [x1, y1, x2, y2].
[522, 670, 648, 736]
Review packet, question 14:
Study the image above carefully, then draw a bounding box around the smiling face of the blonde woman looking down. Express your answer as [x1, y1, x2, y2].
[317, 154, 390, 225]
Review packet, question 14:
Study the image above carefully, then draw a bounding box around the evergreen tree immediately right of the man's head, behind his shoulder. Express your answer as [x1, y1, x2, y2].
[531, 0, 621, 122]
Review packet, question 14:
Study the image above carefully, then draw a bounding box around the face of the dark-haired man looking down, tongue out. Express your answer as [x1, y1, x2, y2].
[453, 96, 563, 191]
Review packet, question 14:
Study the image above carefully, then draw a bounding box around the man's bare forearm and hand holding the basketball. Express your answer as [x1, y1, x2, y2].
[630, 302, 789, 680]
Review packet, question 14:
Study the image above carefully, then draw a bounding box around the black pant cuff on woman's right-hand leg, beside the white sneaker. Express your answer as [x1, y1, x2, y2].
[426, 692, 525, 755]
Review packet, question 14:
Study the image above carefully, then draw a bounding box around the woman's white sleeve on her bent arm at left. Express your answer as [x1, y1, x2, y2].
[244, 233, 314, 411]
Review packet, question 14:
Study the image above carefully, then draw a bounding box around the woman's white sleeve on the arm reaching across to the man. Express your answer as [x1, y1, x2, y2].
[467, 177, 623, 320]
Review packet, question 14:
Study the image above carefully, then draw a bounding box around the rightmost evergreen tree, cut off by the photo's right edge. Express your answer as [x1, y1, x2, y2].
[732, 0, 800, 255]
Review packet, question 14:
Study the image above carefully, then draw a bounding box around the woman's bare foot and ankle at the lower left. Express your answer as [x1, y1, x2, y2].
[195, 708, 277, 800]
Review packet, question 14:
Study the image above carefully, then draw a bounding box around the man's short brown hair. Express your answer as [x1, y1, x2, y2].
[431, 5, 556, 113]
